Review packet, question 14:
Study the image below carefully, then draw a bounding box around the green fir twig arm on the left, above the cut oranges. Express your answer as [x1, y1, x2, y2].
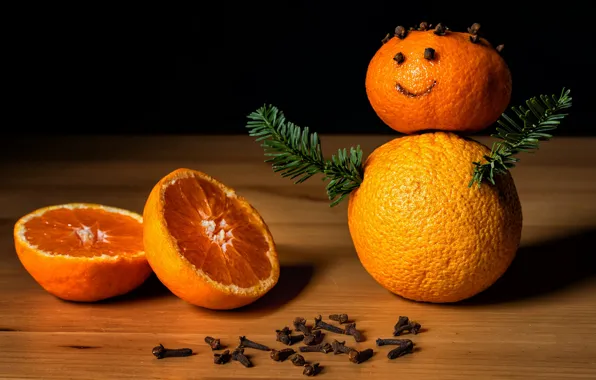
[246, 105, 363, 207]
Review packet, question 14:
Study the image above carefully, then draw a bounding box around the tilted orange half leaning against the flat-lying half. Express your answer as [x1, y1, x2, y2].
[143, 168, 279, 309]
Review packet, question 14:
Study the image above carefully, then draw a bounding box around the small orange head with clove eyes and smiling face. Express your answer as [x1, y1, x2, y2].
[365, 26, 511, 134]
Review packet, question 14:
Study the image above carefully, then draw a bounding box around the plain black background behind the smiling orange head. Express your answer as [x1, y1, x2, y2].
[16, 1, 596, 135]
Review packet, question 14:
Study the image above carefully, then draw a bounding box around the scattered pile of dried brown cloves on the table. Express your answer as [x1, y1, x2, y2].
[152, 314, 422, 376]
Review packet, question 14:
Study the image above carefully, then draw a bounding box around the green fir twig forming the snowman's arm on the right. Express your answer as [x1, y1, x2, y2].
[468, 88, 572, 187]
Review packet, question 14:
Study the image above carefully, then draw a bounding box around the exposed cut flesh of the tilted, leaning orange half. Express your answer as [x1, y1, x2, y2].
[164, 177, 272, 288]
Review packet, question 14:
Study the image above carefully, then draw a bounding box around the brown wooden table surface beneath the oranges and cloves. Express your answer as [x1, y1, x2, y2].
[0, 136, 596, 380]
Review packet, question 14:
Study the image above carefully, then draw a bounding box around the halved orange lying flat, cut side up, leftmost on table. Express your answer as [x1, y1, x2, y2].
[14, 203, 151, 302]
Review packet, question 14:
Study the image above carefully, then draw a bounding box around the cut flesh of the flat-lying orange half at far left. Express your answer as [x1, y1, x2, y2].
[25, 208, 143, 257]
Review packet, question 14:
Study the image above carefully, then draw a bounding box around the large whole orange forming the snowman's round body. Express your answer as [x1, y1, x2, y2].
[348, 132, 522, 303]
